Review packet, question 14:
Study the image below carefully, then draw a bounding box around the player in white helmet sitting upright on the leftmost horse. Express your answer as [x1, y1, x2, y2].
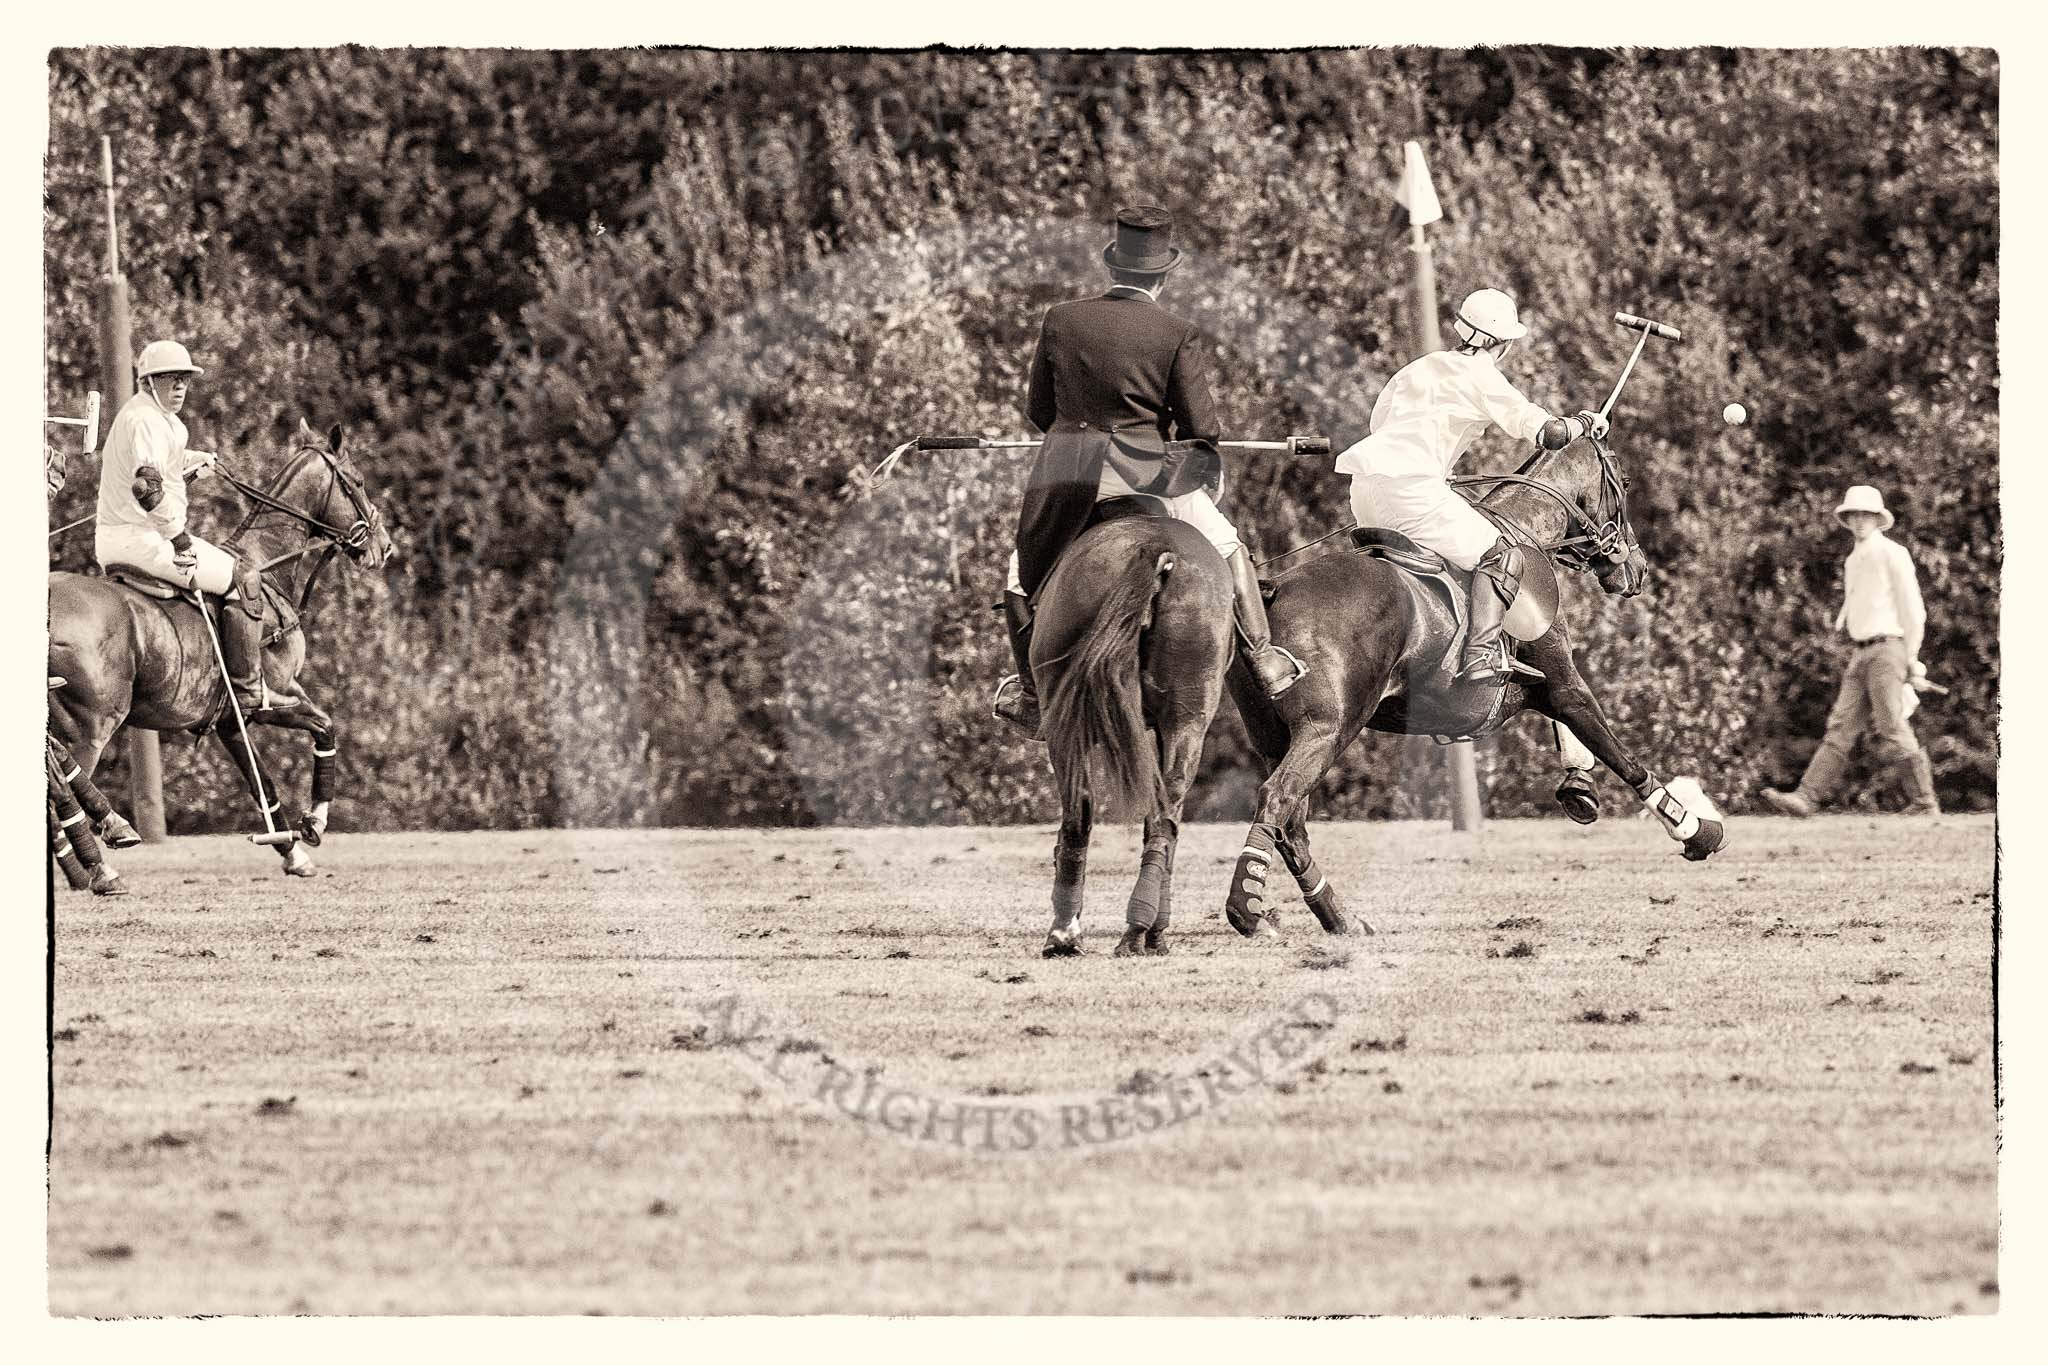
[92, 342, 297, 712]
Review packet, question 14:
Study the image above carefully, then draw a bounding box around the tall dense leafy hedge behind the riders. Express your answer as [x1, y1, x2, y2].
[43, 49, 2001, 831]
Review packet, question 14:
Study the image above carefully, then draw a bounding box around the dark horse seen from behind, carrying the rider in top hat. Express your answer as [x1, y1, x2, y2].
[1030, 499, 1235, 958]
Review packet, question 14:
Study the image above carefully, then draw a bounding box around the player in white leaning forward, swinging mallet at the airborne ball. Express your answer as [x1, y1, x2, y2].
[1337, 289, 1608, 686]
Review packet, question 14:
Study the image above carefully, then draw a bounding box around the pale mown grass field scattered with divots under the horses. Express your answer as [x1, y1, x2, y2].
[49, 814, 1999, 1316]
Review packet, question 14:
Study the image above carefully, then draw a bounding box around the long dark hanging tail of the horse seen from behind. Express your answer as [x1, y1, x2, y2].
[1042, 553, 1174, 812]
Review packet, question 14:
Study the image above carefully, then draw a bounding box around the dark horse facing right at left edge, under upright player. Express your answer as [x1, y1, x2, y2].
[49, 422, 391, 876]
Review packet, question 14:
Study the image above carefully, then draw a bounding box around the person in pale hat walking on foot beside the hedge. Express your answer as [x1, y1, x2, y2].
[1763, 483, 1942, 817]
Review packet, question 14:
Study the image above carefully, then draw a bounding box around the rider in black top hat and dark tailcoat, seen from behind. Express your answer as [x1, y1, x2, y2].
[995, 205, 1307, 735]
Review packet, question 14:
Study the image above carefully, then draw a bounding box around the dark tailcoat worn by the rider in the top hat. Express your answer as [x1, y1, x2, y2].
[1018, 289, 1221, 593]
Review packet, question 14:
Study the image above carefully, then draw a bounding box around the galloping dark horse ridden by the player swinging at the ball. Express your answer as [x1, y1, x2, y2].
[1225, 440, 1722, 937]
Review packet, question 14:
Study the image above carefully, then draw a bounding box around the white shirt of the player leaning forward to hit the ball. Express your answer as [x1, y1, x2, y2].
[1337, 350, 1550, 479]
